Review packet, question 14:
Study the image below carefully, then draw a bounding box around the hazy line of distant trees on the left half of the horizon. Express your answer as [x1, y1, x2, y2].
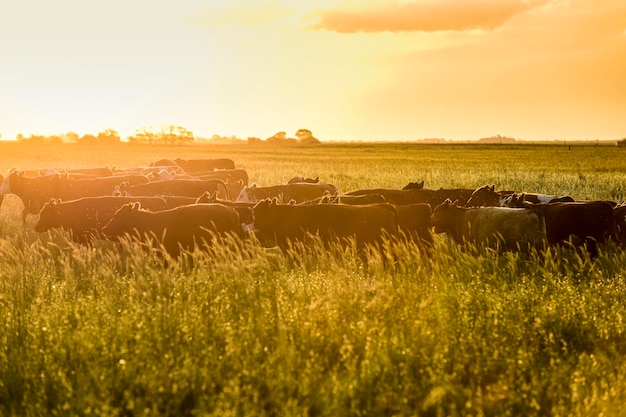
[6, 126, 320, 145]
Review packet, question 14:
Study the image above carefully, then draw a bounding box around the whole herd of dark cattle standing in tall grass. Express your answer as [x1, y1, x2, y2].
[0, 159, 626, 257]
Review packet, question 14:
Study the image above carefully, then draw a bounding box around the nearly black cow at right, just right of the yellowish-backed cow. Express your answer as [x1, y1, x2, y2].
[526, 201, 616, 257]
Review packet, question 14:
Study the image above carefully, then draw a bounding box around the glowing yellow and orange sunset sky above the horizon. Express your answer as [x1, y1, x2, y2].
[0, 0, 626, 141]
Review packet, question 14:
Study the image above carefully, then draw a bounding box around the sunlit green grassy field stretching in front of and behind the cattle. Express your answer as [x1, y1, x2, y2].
[0, 142, 626, 416]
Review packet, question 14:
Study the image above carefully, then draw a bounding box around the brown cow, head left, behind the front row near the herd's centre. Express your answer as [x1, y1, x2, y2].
[236, 183, 337, 204]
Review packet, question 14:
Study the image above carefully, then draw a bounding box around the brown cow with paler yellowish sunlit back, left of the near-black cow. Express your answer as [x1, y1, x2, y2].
[430, 200, 546, 250]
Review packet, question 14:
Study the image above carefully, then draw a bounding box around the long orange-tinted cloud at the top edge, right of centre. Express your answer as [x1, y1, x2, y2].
[314, 0, 549, 33]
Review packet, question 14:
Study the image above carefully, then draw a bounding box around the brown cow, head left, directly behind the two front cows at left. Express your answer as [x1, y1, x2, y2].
[117, 179, 230, 200]
